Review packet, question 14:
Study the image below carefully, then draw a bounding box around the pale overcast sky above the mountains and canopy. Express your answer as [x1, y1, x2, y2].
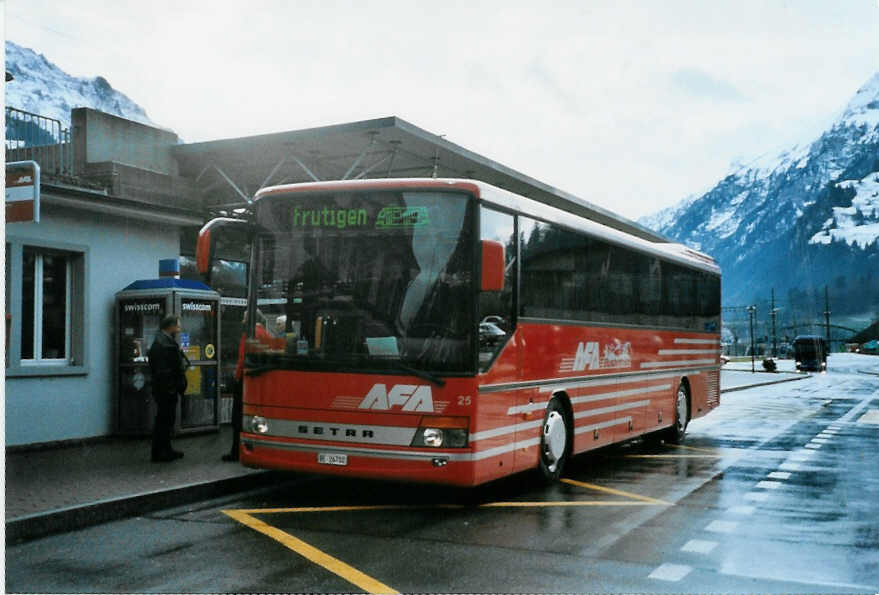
[5, 0, 879, 218]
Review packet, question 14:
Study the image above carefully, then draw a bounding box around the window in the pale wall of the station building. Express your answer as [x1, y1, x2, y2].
[6, 240, 86, 376]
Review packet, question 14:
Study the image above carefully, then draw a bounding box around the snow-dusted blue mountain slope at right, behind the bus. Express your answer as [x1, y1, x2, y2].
[639, 73, 879, 310]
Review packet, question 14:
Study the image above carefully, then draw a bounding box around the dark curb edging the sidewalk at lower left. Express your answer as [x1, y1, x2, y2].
[6, 471, 285, 545]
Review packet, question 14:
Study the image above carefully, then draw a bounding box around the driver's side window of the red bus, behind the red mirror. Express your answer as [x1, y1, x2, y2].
[479, 207, 516, 372]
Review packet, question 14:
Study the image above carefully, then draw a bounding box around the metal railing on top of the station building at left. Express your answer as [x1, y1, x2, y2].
[6, 107, 73, 176]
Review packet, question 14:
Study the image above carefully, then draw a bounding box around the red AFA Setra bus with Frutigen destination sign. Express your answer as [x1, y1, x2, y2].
[198, 179, 720, 486]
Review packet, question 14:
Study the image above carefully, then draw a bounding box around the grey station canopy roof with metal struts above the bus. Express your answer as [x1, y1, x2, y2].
[174, 116, 669, 242]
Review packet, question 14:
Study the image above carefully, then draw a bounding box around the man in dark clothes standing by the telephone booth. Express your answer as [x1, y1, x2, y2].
[149, 315, 186, 463]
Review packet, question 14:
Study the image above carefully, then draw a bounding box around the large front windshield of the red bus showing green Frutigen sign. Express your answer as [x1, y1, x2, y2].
[248, 191, 476, 374]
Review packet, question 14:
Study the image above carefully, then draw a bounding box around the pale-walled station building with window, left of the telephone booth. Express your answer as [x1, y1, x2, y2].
[5, 109, 204, 447]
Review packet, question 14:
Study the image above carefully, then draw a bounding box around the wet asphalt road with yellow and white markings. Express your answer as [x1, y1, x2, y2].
[6, 355, 879, 593]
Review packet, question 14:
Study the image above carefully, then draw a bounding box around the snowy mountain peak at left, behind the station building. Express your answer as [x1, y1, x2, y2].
[6, 41, 158, 128]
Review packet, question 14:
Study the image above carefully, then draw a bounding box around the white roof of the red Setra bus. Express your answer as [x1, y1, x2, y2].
[254, 178, 720, 274]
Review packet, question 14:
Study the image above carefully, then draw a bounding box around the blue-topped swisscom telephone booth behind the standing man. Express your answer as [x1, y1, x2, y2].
[116, 278, 220, 434]
